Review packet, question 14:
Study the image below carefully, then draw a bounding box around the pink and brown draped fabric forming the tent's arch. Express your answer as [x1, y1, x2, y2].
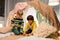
[6, 0, 59, 27]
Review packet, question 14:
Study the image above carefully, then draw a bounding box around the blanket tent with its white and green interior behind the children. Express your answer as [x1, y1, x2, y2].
[6, 0, 59, 37]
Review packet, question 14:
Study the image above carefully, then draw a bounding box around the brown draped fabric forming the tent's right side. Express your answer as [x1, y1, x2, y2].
[28, 1, 59, 27]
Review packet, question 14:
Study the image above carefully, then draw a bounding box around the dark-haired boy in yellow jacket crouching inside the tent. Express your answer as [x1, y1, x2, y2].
[24, 15, 37, 34]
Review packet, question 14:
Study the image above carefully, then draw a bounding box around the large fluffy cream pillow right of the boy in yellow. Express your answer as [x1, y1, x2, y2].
[33, 22, 57, 37]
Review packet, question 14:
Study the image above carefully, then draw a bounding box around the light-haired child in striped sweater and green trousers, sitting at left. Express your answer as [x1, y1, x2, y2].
[11, 10, 24, 35]
